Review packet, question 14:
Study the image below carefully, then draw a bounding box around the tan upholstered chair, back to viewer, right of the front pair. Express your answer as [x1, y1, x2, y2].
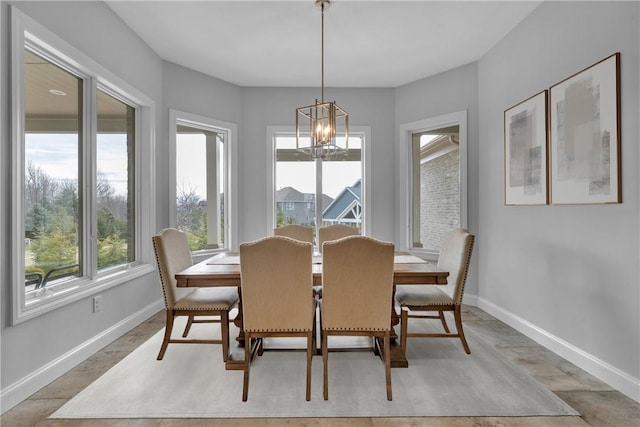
[320, 236, 394, 400]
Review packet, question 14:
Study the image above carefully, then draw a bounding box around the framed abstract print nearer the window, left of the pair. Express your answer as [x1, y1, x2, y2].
[504, 90, 549, 206]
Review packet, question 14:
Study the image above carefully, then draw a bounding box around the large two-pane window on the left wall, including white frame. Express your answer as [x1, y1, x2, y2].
[12, 8, 155, 323]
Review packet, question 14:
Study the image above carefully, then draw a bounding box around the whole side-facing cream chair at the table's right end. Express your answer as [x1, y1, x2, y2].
[396, 228, 475, 354]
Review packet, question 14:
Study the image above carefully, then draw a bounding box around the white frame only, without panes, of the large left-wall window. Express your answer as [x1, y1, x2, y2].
[10, 7, 156, 325]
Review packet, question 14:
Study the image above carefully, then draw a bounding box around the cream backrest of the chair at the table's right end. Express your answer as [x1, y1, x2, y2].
[438, 228, 475, 304]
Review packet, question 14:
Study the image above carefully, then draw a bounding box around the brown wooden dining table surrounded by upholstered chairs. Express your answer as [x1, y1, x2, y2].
[175, 252, 449, 370]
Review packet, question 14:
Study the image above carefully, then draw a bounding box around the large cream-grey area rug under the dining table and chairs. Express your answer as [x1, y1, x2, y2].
[51, 312, 579, 418]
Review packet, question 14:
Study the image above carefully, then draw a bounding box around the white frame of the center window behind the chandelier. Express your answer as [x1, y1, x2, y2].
[265, 126, 372, 236]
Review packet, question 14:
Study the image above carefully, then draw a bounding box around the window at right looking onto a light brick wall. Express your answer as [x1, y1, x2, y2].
[399, 112, 466, 259]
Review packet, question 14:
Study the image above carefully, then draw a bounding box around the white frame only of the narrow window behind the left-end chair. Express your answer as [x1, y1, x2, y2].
[169, 108, 239, 261]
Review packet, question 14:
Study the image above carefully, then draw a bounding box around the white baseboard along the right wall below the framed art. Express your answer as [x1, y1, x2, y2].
[478, 296, 640, 402]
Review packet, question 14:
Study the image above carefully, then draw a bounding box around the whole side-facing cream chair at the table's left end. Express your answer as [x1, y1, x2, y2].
[152, 228, 238, 361]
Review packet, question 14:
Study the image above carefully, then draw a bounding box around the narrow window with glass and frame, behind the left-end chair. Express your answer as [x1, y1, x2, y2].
[169, 110, 237, 256]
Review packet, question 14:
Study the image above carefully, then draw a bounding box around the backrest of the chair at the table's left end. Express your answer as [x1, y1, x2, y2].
[152, 228, 193, 308]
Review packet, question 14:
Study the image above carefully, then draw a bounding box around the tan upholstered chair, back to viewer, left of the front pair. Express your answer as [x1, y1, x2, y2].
[240, 236, 316, 401]
